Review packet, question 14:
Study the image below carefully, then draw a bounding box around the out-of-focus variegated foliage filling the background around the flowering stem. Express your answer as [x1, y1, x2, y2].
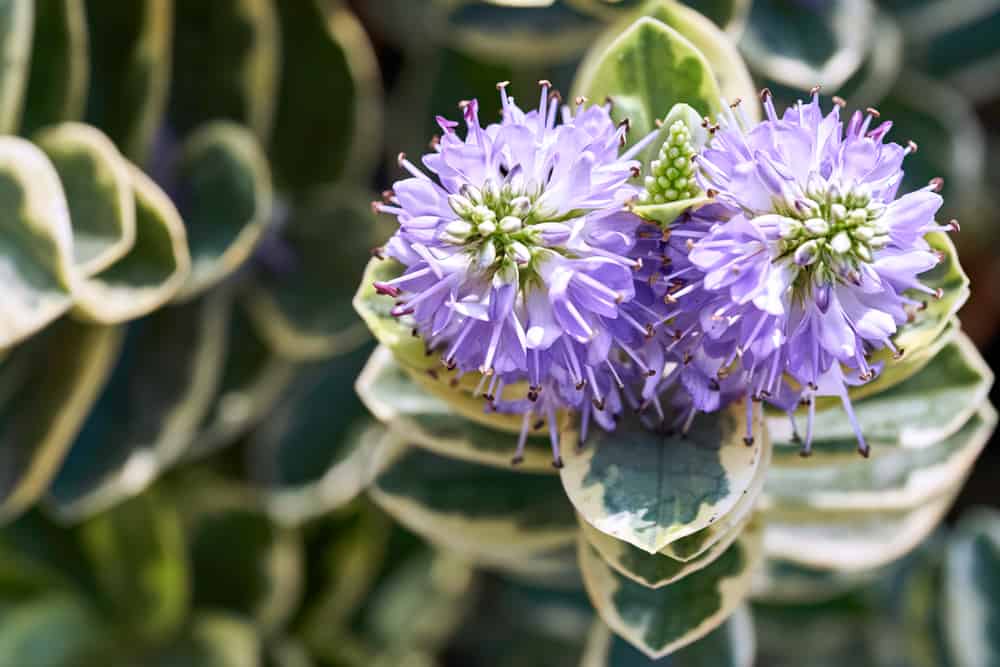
[0, 0, 1000, 667]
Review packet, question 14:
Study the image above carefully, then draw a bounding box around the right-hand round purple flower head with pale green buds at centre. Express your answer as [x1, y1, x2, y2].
[665, 91, 950, 454]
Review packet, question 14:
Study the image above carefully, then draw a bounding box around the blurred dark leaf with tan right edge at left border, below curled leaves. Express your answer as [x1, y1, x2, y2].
[0, 319, 121, 520]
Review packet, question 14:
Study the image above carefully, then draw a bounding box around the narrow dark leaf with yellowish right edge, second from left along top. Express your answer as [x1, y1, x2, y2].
[20, 0, 88, 134]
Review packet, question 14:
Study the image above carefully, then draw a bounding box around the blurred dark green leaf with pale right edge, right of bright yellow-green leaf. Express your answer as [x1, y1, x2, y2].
[190, 508, 304, 636]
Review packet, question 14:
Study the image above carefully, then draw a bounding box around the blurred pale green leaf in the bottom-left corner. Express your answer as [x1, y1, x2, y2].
[0, 593, 110, 667]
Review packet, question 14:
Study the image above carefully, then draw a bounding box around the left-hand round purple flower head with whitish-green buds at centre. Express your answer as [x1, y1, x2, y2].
[375, 81, 656, 463]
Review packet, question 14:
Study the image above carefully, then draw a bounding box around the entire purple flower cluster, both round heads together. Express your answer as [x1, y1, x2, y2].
[375, 81, 946, 466]
